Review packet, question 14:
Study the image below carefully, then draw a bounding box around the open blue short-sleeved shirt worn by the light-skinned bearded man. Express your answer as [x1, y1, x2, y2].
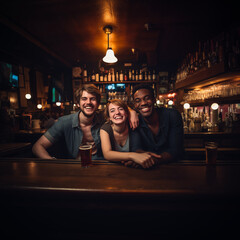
[44, 111, 104, 159]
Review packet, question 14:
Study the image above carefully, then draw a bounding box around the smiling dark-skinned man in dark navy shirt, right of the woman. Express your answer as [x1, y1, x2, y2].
[127, 84, 183, 165]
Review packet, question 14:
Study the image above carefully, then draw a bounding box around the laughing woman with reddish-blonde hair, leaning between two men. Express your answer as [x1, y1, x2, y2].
[100, 99, 158, 168]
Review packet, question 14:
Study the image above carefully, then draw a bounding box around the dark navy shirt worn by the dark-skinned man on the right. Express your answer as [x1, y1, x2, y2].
[132, 108, 184, 158]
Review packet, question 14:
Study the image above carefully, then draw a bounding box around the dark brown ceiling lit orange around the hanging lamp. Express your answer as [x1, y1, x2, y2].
[0, 0, 239, 70]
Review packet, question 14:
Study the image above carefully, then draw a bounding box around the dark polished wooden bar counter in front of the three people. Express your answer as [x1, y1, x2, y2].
[0, 158, 240, 239]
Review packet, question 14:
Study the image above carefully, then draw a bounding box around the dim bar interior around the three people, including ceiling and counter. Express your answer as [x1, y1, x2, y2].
[0, 0, 240, 239]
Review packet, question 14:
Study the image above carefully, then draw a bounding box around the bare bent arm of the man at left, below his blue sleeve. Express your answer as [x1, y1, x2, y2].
[32, 135, 53, 159]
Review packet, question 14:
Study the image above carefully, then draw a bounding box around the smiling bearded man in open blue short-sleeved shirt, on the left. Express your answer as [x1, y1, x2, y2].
[32, 84, 137, 159]
